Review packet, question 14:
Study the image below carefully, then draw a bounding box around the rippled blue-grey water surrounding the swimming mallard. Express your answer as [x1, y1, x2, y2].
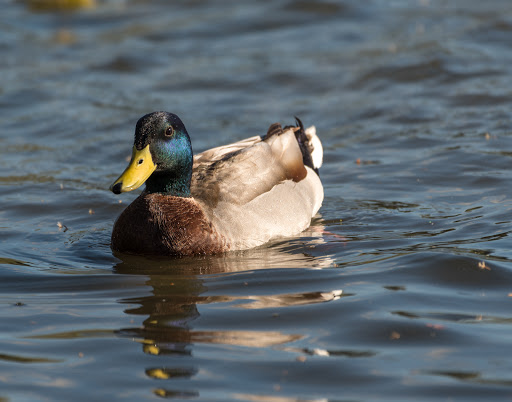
[0, 0, 512, 402]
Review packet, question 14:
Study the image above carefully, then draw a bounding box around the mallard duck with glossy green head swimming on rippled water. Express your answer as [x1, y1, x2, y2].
[110, 112, 324, 256]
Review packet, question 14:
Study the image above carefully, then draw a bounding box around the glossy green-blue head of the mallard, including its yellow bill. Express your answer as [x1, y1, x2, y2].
[110, 112, 193, 197]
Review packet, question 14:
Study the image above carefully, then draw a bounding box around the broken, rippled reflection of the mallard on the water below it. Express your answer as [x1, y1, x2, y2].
[115, 232, 342, 398]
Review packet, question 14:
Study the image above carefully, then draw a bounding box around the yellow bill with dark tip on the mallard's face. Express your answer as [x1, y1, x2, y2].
[110, 145, 156, 194]
